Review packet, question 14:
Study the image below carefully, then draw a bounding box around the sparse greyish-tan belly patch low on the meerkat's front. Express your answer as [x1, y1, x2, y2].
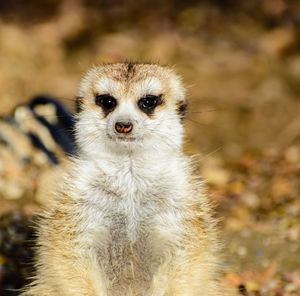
[97, 208, 164, 295]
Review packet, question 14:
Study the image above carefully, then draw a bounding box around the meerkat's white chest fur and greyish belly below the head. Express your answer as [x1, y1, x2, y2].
[69, 151, 186, 295]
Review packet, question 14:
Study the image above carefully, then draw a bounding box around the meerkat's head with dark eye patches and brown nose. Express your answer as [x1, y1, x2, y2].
[76, 63, 187, 157]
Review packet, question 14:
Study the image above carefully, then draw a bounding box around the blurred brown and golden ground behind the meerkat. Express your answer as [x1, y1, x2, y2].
[0, 0, 300, 295]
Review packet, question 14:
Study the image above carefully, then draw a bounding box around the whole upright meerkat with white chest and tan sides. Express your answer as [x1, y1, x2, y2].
[22, 63, 231, 296]
